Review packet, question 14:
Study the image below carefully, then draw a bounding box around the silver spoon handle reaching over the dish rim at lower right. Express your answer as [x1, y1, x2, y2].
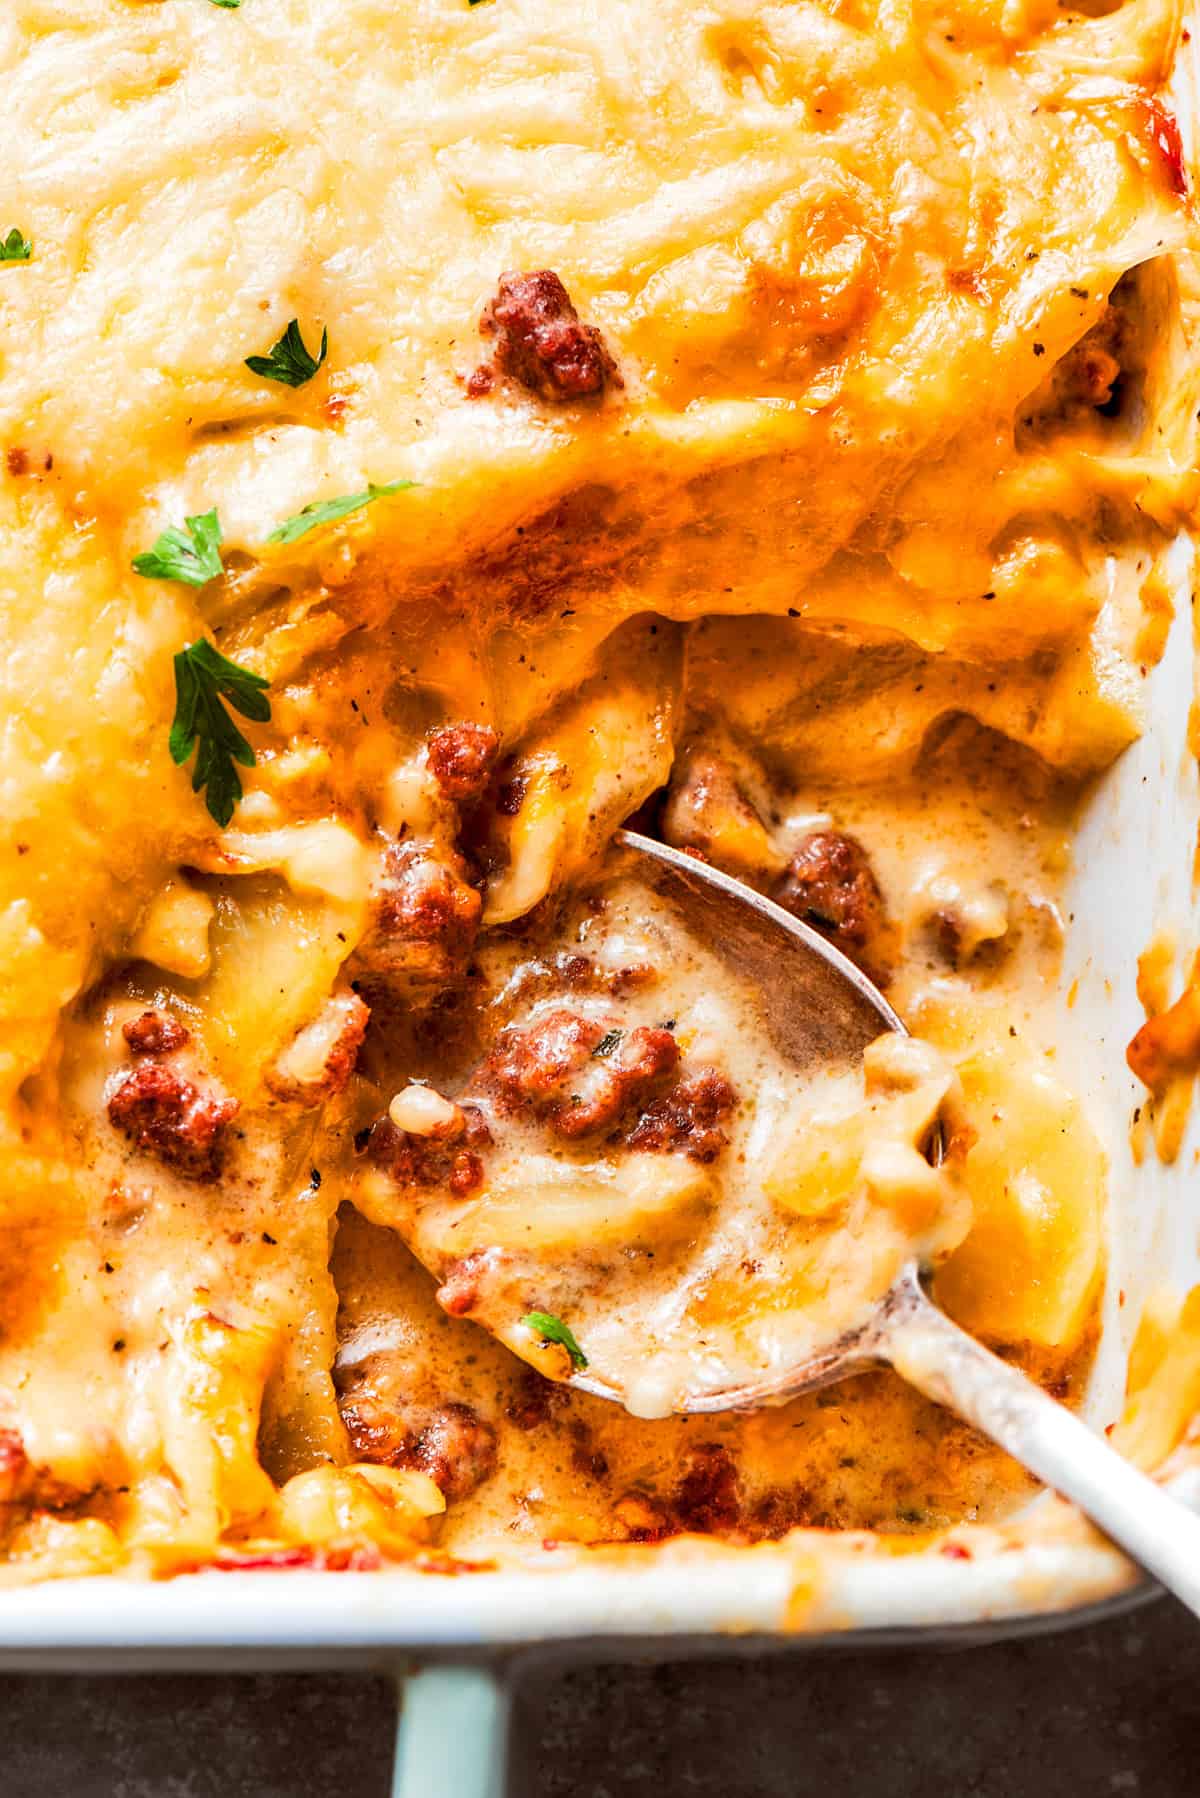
[878, 1275, 1200, 1616]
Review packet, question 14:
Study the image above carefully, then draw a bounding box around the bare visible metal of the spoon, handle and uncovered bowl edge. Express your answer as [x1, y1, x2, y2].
[572, 831, 1200, 1615]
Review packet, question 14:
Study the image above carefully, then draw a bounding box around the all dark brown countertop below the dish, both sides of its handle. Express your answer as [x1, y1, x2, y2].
[0, 1600, 1200, 1798]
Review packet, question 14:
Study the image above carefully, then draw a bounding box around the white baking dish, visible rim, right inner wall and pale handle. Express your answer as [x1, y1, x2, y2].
[0, 545, 1200, 1798]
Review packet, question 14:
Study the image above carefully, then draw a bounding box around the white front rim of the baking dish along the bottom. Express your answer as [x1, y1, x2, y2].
[0, 1543, 1158, 1646]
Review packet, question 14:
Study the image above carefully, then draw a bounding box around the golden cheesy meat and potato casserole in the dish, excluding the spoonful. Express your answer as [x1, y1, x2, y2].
[0, 0, 1196, 1577]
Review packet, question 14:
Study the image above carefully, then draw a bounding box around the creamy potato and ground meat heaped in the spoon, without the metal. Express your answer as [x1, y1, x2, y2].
[354, 870, 970, 1417]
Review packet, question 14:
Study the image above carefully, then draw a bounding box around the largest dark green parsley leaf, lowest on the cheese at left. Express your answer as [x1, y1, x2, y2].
[167, 636, 272, 829]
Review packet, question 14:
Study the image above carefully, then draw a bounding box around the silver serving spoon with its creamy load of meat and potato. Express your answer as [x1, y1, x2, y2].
[372, 831, 1200, 1615]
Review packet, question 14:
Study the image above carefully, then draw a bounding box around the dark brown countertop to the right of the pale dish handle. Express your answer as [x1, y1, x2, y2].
[515, 1602, 1200, 1798]
